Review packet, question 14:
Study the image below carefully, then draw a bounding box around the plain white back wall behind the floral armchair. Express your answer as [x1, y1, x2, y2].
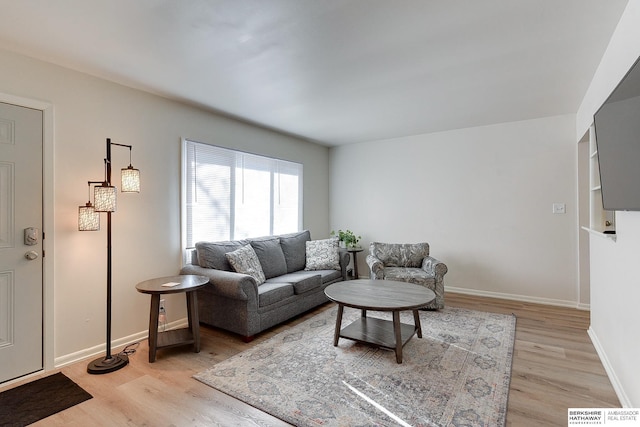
[330, 115, 581, 306]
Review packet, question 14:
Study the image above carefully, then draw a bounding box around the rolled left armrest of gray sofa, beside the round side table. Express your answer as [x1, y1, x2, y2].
[180, 264, 258, 301]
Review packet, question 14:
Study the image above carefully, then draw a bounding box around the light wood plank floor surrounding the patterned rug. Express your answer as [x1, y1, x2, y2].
[0, 294, 620, 427]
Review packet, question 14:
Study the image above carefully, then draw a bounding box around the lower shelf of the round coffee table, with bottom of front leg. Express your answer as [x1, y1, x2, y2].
[339, 317, 418, 363]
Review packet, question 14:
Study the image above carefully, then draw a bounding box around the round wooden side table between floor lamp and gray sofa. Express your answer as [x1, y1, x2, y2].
[136, 274, 209, 363]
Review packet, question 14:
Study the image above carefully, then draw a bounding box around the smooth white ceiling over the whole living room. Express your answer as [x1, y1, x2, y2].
[0, 0, 627, 146]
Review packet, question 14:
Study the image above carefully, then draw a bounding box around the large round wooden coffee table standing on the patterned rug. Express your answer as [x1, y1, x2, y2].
[324, 279, 436, 363]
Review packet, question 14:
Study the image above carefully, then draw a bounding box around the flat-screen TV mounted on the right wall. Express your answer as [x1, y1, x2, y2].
[594, 58, 640, 211]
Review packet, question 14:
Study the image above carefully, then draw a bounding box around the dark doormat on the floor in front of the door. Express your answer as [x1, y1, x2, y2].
[0, 372, 93, 426]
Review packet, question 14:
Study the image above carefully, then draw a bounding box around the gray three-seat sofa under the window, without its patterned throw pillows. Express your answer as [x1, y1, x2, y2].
[180, 230, 349, 341]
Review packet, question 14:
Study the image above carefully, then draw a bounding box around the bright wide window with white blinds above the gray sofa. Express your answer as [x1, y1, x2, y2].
[182, 140, 302, 254]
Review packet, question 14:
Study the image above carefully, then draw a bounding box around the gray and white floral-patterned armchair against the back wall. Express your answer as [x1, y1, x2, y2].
[367, 242, 448, 310]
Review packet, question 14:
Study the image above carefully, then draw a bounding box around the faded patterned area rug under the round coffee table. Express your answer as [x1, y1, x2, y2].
[194, 306, 516, 427]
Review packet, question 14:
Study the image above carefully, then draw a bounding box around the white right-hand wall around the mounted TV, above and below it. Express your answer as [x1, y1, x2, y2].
[576, 1, 640, 407]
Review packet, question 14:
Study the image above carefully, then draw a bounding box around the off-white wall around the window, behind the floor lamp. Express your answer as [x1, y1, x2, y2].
[0, 51, 330, 362]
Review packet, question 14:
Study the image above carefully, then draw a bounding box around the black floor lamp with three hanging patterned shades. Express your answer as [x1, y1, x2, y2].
[78, 138, 140, 374]
